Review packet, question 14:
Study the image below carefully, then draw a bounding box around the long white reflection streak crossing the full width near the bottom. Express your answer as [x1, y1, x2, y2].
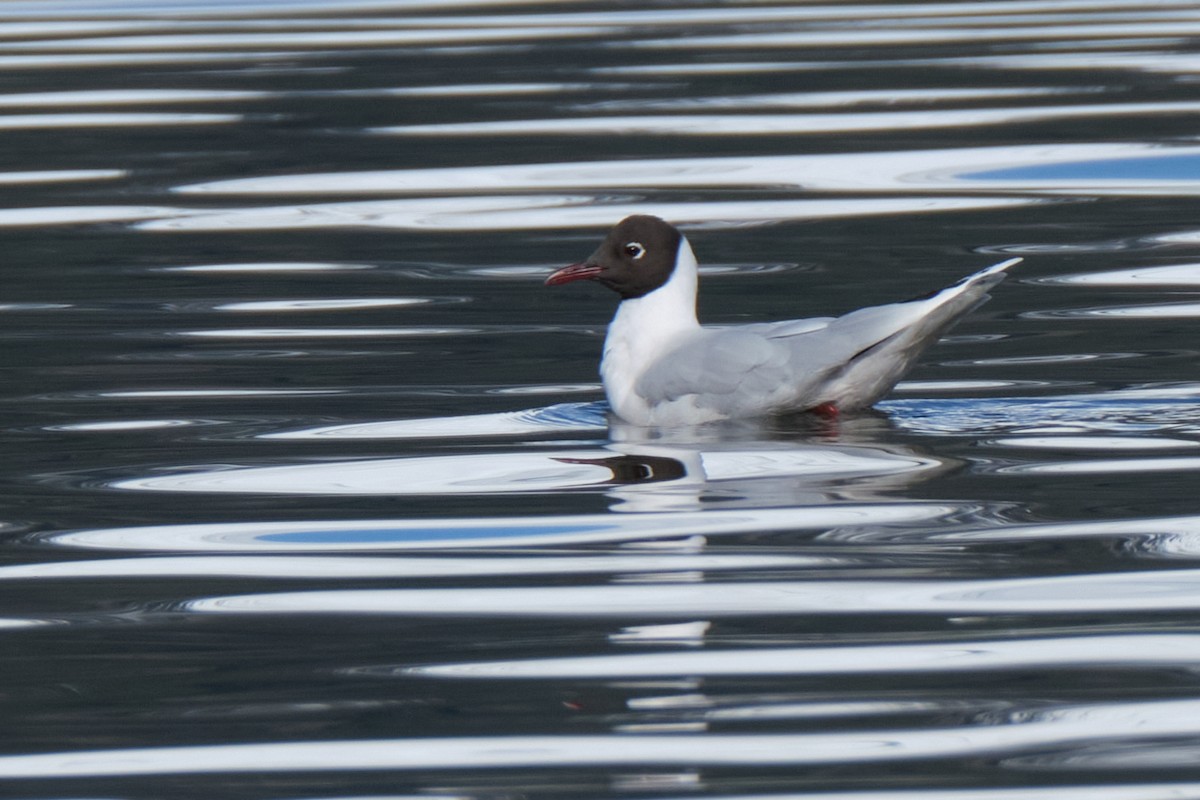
[0, 699, 1200, 777]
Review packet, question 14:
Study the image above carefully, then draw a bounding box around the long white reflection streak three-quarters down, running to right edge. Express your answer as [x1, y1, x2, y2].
[188, 570, 1200, 619]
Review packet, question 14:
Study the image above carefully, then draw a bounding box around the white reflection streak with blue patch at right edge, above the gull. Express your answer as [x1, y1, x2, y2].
[173, 143, 1200, 196]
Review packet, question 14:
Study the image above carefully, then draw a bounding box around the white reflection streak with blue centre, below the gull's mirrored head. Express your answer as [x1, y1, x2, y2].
[54, 501, 964, 553]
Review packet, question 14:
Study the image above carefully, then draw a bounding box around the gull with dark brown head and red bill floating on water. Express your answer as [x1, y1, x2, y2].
[546, 215, 1021, 427]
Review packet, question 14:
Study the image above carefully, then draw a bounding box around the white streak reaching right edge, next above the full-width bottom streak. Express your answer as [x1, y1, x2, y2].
[415, 633, 1200, 680]
